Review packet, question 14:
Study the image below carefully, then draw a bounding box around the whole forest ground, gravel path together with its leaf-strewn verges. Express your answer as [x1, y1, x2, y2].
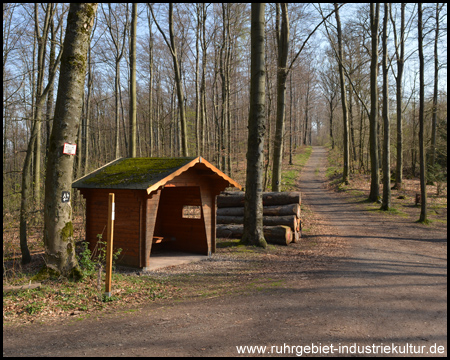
[3, 147, 447, 356]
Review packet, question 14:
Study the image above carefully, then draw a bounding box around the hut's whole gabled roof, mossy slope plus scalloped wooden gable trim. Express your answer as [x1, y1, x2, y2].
[72, 157, 241, 192]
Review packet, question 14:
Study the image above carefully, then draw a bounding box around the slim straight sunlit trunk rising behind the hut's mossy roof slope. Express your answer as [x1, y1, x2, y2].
[129, 3, 137, 158]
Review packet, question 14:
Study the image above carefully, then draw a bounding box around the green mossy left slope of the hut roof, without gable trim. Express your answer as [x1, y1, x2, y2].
[73, 158, 194, 189]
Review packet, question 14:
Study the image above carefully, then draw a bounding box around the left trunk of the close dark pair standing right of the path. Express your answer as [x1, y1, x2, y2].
[369, 3, 380, 201]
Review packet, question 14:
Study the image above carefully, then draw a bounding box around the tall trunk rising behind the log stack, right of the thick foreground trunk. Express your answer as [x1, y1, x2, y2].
[272, 3, 289, 191]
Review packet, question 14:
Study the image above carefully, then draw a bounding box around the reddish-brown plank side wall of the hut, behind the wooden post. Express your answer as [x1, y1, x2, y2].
[80, 189, 147, 267]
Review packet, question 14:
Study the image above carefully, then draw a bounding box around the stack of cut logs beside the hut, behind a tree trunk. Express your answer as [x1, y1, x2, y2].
[216, 191, 302, 245]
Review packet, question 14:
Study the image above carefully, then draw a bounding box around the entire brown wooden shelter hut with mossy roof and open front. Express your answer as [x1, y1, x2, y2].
[72, 157, 242, 269]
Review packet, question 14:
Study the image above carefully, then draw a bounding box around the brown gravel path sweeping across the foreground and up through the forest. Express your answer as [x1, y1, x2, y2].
[3, 147, 447, 356]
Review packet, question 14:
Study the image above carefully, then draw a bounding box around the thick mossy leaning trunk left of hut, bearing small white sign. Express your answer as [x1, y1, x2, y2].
[44, 3, 97, 278]
